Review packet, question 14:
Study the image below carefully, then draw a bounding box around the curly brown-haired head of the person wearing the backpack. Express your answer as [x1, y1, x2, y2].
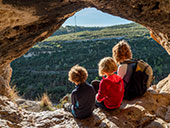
[112, 40, 132, 64]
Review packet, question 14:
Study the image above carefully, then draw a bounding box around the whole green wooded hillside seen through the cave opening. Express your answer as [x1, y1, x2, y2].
[11, 23, 170, 102]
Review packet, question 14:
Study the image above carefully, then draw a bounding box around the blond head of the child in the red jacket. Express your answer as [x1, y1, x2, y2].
[98, 57, 117, 76]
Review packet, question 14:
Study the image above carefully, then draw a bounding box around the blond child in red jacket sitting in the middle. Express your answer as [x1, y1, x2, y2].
[92, 57, 124, 109]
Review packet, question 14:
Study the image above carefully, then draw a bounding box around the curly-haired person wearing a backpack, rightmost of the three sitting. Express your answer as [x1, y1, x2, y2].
[112, 40, 153, 100]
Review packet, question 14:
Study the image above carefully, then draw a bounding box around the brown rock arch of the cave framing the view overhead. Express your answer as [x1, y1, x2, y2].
[0, 0, 170, 94]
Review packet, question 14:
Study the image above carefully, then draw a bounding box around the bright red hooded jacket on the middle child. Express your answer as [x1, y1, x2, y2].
[97, 74, 124, 109]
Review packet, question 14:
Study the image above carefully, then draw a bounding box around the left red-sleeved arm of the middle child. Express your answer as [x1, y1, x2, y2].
[96, 80, 106, 102]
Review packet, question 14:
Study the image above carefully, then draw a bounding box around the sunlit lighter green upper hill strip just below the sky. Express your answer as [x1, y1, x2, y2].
[43, 23, 149, 42]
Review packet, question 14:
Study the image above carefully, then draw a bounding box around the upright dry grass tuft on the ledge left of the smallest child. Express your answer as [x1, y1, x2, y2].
[40, 93, 54, 111]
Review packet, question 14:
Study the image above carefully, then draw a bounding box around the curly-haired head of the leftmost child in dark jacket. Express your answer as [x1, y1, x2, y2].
[68, 65, 88, 85]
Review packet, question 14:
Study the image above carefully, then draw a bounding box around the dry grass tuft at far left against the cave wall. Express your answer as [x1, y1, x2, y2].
[7, 84, 19, 101]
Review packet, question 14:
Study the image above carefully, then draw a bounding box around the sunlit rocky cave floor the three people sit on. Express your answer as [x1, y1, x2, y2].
[0, 76, 170, 128]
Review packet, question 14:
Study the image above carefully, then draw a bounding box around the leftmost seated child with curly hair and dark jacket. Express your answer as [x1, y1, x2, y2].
[64, 65, 95, 119]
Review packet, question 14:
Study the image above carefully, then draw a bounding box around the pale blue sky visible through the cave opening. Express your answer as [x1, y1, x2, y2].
[63, 8, 132, 26]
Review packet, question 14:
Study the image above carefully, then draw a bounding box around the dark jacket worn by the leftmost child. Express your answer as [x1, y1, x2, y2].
[71, 82, 95, 119]
